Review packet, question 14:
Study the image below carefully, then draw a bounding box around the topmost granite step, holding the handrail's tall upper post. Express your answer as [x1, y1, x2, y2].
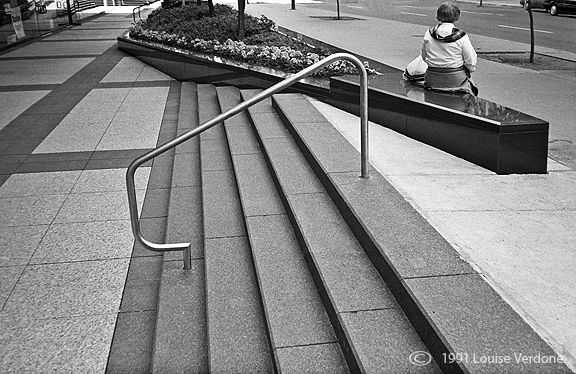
[272, 95, 570, 373]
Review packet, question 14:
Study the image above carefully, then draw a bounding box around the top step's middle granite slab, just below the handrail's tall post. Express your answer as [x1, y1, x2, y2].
[330, 173, 475, 286]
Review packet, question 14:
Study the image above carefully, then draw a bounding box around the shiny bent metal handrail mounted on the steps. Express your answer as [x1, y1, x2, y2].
[126, 53, 369, 270]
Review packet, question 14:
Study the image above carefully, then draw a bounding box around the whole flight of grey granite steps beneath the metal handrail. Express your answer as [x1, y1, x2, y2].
[146, 82, 565, 373]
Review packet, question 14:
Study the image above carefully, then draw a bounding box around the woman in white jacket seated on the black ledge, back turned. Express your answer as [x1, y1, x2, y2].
[422, 2, 478, 95]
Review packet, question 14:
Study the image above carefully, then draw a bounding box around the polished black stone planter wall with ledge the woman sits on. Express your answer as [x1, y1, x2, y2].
[118, 33, 549, 174]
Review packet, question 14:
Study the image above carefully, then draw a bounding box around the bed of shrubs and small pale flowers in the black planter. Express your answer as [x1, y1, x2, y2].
[130, 4, 374, 76]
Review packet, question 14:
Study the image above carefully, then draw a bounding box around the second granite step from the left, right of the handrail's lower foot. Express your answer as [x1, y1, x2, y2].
[198, 84, 273, 373]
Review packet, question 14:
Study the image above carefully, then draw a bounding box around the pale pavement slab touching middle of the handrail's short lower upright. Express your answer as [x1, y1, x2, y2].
[54, 190, 145, 223]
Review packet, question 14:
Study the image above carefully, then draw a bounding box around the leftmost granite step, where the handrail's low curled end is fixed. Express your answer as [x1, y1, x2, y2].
[152, 82, 208, 373]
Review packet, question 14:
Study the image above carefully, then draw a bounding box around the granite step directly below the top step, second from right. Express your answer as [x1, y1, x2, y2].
[242, 90, 439, 373]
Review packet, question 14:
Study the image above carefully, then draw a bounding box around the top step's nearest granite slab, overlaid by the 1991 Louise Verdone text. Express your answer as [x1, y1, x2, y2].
[404, 274, 571, 373]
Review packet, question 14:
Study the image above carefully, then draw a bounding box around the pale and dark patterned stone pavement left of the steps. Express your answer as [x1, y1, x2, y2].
[0, 7, 175, 373]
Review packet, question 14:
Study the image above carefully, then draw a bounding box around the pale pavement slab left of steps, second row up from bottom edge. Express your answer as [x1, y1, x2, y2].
[0, 259, 130, 320]
